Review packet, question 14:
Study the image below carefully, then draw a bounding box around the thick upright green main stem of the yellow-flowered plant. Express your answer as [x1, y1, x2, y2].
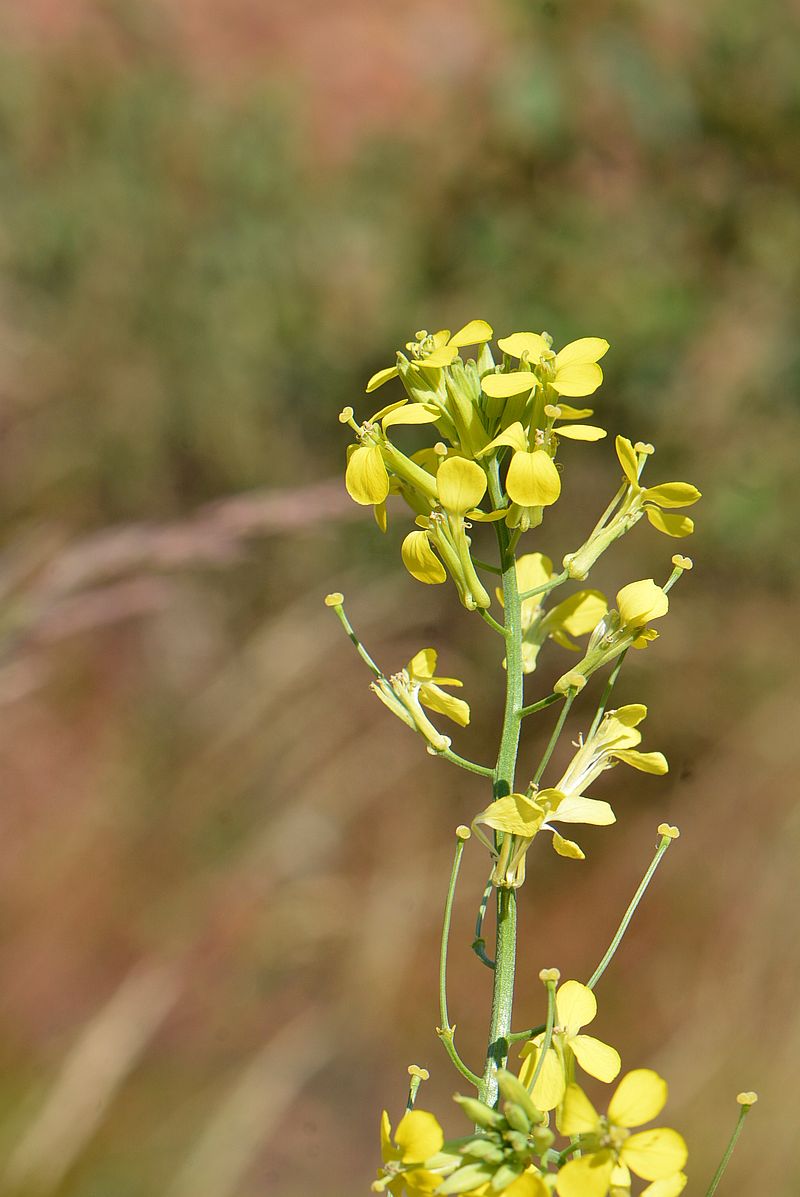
[479, 463, 522, 1106]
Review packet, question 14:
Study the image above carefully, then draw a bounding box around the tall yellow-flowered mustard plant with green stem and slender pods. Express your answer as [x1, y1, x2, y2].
[326, 320, 757, 1197]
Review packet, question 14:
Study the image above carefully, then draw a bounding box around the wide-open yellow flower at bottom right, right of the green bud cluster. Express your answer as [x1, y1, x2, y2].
[556, 1068, 689, 1197]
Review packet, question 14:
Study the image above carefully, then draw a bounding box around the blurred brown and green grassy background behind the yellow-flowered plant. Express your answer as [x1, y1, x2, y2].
[0, 0, 800, 1197]
